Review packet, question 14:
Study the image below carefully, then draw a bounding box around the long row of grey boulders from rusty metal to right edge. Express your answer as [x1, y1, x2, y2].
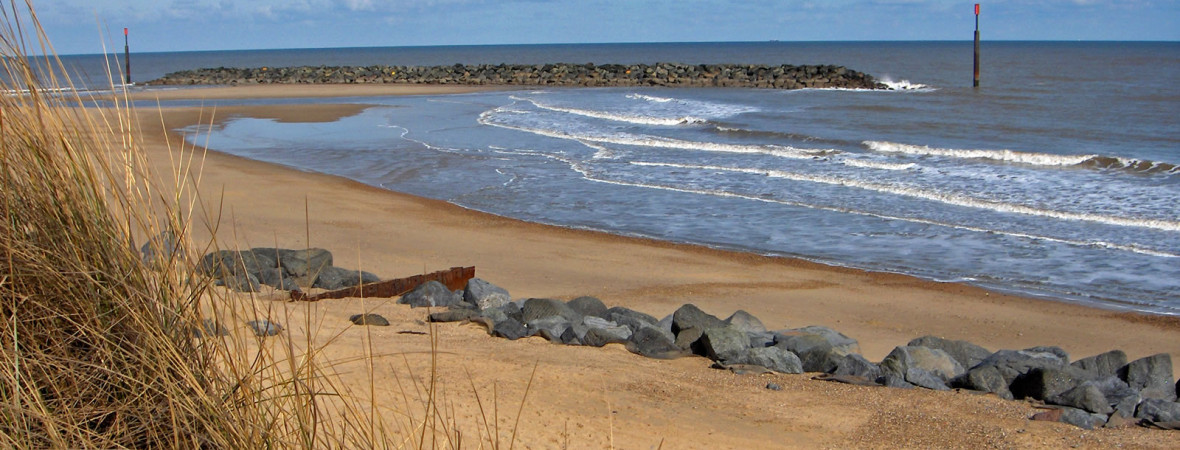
[424, 279, 1180, 429]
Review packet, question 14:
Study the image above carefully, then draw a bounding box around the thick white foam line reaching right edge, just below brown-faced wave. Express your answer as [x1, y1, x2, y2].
[631, 161, 1180, 231]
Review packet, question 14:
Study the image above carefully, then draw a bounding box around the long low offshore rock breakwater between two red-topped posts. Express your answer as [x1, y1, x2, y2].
[146, 63, 889, 90]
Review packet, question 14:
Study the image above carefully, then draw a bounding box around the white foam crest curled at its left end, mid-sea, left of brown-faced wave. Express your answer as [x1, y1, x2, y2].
[478, 106, 835, 159]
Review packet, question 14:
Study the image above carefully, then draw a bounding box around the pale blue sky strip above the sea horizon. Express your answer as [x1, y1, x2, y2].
[25, 0, 1180, 54]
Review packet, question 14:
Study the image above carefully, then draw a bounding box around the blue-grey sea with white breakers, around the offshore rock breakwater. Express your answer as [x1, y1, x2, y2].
[53, 41, 1180, 315]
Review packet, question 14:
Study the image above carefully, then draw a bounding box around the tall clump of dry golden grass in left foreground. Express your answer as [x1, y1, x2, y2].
[0, 2, 531, 449]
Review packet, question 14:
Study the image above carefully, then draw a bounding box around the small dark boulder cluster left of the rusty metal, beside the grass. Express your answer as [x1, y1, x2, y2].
[199, 248, 381, 292]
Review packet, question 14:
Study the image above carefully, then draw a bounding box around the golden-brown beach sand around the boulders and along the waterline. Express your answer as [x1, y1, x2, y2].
[124, 86, 1180, 449]
